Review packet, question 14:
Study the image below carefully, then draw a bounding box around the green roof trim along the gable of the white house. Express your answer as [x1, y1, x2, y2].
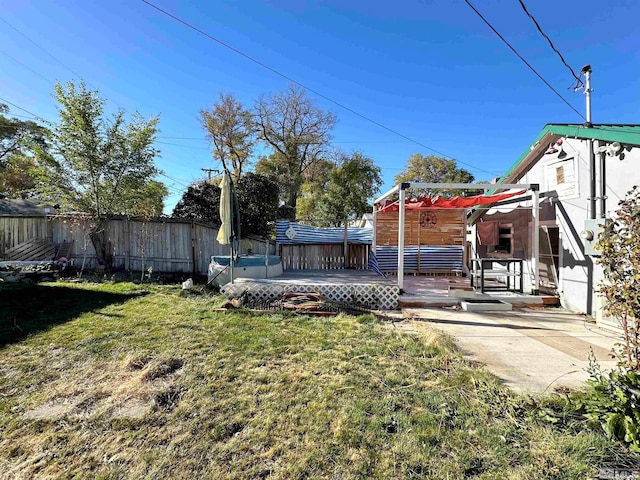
[487, 123, 640, 193]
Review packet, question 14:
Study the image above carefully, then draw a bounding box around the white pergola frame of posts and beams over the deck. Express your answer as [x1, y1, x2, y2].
[373, 182, 540, 295]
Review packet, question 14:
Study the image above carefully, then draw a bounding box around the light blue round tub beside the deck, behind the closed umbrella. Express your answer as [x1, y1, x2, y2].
[208, 255, 282, 286]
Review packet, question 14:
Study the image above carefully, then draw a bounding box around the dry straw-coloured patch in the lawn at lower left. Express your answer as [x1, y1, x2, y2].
[24, 356, 184, 420]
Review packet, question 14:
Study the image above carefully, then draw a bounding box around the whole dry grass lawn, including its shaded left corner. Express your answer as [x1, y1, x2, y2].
[0, 283, 633, 479]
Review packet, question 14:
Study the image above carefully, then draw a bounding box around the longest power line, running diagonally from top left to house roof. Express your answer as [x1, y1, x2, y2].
[140, 0, 500, 174]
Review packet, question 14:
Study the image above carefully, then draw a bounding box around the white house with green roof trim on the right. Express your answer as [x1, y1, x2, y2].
[469, 124, 640, 324]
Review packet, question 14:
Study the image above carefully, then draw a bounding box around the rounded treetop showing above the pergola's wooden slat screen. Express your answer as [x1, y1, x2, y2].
[395, 153, 474, 197]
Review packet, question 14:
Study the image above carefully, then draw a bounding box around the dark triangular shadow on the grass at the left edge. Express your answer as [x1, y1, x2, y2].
[0, 284, 147, 348]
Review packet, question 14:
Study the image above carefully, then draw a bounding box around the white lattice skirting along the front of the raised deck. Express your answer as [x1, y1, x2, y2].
[220, 282, 399, 310]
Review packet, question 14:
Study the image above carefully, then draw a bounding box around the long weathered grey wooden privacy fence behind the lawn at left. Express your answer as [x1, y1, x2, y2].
[0, 215, 275, 275]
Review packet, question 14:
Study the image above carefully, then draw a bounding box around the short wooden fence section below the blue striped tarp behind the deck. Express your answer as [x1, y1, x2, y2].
[280, 244, 371, 270]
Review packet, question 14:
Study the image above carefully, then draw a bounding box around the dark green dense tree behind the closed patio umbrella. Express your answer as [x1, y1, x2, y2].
[173, 172, 278, 237]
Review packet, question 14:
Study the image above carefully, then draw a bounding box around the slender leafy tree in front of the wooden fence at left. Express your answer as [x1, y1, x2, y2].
[39, 82, 159, 268]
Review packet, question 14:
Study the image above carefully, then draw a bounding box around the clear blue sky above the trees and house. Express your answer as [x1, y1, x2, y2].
[0, 0, 640, 212]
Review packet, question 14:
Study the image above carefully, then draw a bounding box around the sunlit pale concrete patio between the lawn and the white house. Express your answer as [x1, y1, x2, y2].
[394, 308, 621, 394]
